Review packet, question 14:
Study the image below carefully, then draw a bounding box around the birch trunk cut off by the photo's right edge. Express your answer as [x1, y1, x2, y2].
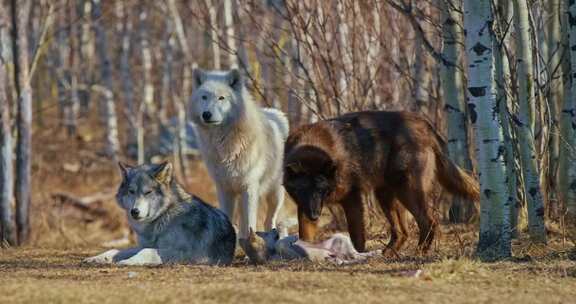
[559, 1, 576, 238]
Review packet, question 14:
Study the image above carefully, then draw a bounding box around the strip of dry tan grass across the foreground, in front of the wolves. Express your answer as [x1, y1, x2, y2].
[0, 249, 576, 304]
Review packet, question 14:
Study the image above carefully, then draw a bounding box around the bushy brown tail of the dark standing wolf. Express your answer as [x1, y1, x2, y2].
[436, 150, 480, 201]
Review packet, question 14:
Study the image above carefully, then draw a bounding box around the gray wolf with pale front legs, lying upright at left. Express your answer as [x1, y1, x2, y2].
[84, 162, 236, 265]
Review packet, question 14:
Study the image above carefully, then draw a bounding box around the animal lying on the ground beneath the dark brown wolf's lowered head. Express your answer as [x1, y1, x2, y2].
[240, 229, 382, 265]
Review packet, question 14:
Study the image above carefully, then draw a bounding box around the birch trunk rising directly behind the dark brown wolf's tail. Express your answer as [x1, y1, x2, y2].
[440, 0, 475, 222]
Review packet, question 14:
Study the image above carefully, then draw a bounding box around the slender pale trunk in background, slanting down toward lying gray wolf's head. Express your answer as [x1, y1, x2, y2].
[92, 0, 120, 161]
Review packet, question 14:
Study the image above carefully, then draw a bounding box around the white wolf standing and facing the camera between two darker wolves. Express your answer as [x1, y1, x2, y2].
[188, 69, 288, 238]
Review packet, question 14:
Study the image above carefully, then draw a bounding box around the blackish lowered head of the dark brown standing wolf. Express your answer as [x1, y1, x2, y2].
[284, 147, 336, 221]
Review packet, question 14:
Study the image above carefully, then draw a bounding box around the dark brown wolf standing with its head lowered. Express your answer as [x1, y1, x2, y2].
[284, 111, 480, 253]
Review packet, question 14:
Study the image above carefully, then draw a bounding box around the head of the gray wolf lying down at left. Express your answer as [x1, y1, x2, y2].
[116, 163, 173, 222]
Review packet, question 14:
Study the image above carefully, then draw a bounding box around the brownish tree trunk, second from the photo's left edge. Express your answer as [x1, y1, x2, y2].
[11, 0, 32, 245]
